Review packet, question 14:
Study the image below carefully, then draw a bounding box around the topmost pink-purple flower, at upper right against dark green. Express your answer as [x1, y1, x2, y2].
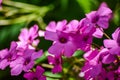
[86, 3, 112, 29]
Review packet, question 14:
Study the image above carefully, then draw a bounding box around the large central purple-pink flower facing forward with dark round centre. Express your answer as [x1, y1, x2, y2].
[45, 31, 80, 57]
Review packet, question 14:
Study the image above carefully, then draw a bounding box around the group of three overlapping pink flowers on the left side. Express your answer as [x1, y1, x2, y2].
[0, 25, 43, 78]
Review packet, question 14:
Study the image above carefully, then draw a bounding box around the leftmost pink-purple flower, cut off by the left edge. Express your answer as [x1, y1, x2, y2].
[0, 42, 17, 70]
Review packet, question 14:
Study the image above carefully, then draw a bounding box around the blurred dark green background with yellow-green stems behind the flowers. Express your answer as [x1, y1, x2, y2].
[0, 0, 120, 80]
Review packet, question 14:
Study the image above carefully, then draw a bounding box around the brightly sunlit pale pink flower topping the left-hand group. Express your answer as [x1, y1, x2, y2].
[17, 25, 39, 49]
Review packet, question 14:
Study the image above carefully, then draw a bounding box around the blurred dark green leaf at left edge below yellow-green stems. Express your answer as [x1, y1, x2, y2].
[0, 23, 25, 49]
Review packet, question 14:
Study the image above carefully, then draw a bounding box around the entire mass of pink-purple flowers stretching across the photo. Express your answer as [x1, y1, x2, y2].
[0, 2, 120, 80]
